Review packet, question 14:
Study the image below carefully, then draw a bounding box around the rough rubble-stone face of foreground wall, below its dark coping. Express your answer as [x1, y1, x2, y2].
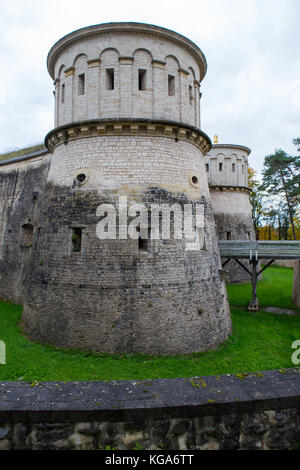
[0, 408, 300, 451]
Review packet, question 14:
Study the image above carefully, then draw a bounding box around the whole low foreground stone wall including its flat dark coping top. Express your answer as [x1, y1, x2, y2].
[0, 368, 300, 451]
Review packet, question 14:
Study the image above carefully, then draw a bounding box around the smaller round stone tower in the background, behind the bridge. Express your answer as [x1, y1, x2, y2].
[205, 139, 255, 282]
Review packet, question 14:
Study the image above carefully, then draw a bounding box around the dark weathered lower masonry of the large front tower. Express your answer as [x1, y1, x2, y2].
[22, 185, 231, 354]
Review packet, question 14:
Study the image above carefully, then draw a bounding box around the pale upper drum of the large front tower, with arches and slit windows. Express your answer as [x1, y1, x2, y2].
[53, 26, 204, 127]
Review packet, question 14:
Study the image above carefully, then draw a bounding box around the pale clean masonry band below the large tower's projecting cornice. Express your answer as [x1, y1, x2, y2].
[48, 134, 209, 194]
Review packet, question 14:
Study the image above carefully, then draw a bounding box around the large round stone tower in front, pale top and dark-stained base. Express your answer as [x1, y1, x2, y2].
[22, 23, 231, 354]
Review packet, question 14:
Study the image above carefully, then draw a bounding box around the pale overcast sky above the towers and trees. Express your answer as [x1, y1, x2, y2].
[0, 0, 300, 171]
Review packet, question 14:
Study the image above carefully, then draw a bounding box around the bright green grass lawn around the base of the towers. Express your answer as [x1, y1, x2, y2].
[0, 267, 300, 382]
